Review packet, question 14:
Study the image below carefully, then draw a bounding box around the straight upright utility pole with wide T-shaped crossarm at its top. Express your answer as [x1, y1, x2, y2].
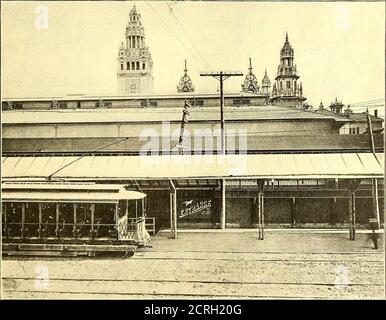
[200, 71, 243, 229]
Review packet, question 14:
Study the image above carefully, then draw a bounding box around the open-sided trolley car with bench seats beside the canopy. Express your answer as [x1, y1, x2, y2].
[2, 182, 150, 256]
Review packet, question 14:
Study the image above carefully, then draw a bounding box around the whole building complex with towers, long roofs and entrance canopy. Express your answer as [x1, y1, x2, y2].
[2, 8, 384, 237]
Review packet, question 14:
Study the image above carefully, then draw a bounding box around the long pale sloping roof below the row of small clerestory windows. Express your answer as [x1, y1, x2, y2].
[2, 105, 350, 125]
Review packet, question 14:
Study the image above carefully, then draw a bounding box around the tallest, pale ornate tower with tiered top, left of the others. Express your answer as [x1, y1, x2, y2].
[117, 5, 154, 95]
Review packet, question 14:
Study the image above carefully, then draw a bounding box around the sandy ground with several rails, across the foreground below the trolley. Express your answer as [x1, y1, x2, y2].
[2, 249, 384, 299]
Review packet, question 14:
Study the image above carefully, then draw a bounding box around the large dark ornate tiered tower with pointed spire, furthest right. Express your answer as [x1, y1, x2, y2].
[271, 33, 306, 107]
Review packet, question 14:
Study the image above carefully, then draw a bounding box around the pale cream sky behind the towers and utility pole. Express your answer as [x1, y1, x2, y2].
[1, 1, 385, 107]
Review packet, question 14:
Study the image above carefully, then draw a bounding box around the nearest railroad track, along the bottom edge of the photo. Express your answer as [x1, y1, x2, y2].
[3, 278, 384, 299]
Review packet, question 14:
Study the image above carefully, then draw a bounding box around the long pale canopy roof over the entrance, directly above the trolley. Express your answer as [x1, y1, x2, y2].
[1, 153, 384, 181]
